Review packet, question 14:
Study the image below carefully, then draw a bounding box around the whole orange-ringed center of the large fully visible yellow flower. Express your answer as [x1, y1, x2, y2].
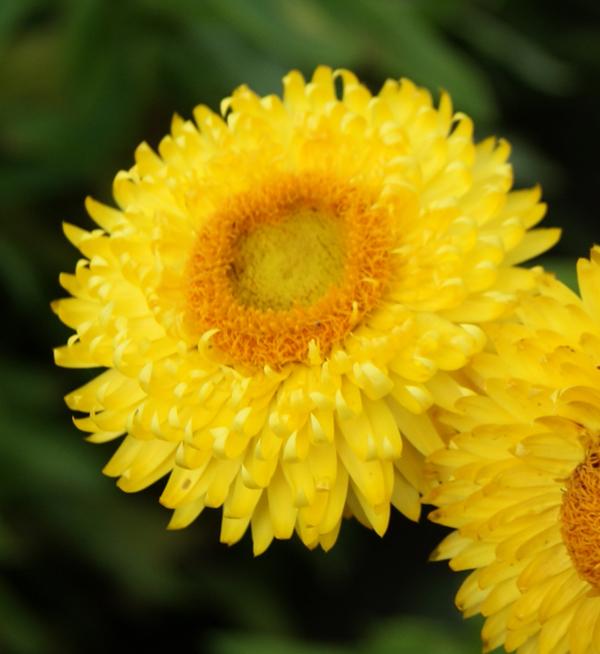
[186, 173, 394, 368]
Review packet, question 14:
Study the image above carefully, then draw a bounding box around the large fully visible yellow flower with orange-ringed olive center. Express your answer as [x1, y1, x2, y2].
[54, 67, 558, 553]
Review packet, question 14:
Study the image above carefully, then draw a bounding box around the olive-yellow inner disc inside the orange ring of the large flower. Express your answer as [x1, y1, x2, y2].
[229, 209, 344, 311]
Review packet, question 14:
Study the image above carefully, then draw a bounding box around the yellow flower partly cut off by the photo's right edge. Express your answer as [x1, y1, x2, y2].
[427, 248, 600, 654]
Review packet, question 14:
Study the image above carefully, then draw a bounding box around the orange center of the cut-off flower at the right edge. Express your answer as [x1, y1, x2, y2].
[561, 444, 600, 590]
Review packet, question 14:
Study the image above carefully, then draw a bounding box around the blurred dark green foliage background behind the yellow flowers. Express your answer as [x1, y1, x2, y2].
[0, 0, 600, 654]
